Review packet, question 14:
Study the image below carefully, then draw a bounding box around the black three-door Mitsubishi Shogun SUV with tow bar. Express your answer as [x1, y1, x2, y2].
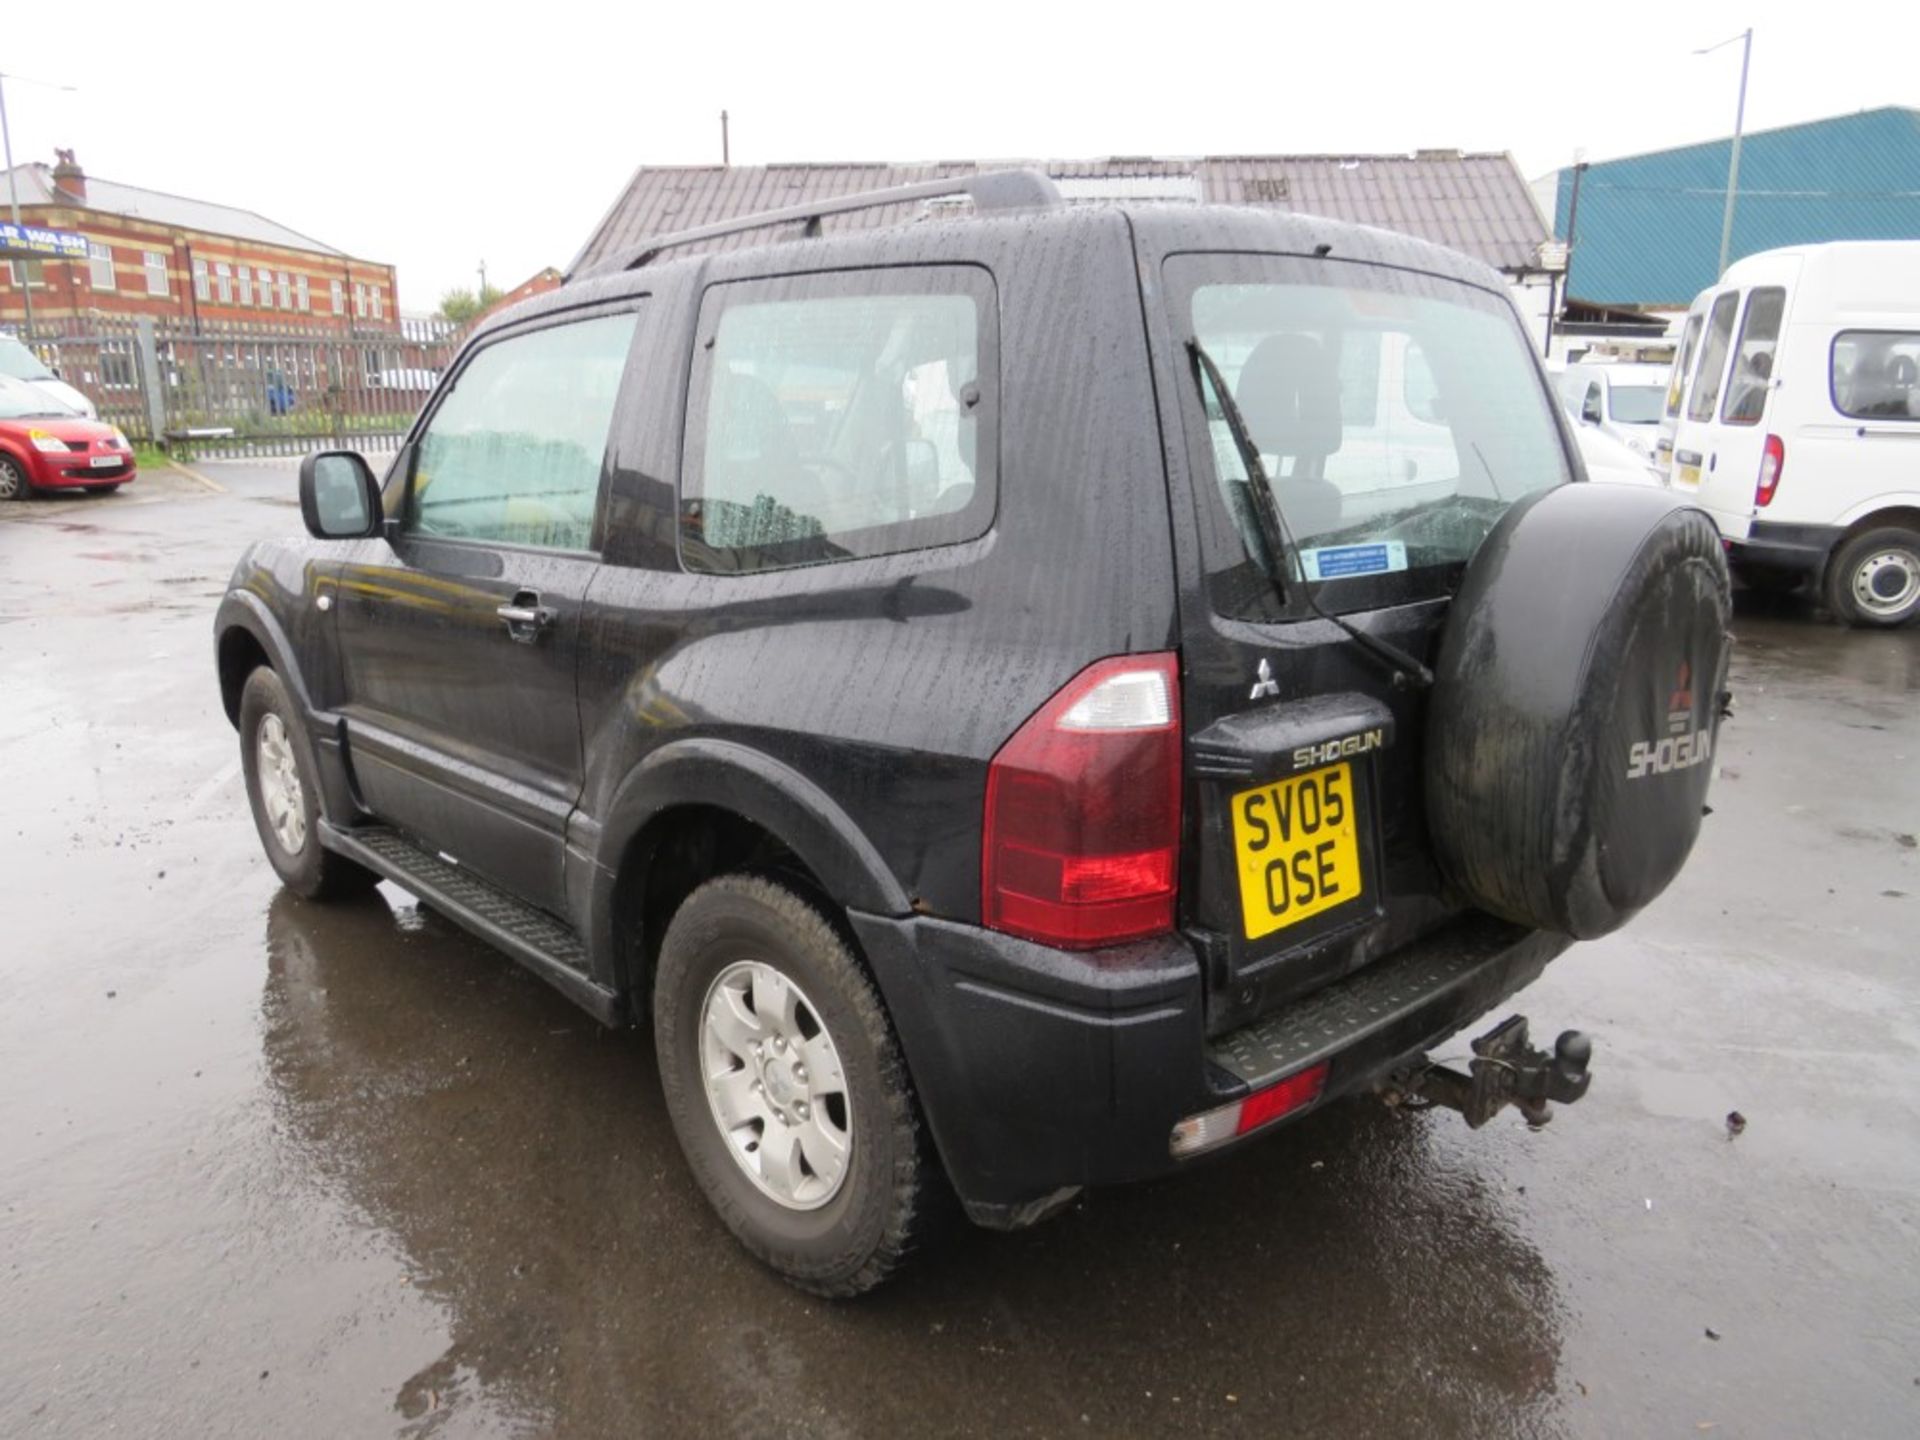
[217, 173, 1728, 1294]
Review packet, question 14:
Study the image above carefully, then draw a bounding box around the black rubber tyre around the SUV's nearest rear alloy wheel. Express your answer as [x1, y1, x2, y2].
[653, 874, 945, 1298]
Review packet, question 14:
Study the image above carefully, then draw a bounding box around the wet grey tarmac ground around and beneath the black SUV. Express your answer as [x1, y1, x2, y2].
[0, 465, 1920, 1436]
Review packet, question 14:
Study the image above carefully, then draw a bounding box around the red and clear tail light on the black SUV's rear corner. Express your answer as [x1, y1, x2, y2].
[981, 655, 1181, 950]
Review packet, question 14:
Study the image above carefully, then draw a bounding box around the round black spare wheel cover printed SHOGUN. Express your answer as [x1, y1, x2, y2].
[1427, 484, 1732, 939]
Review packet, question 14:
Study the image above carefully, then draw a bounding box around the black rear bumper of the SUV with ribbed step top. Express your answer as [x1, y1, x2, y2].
[852, 914, 1571, 1227]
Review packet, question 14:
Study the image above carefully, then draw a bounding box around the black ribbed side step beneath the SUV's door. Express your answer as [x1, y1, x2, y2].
[321, 822, 626, 1025]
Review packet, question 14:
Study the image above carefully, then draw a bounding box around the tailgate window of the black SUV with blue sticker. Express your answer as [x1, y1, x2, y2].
[1167, 255, 1571, 614]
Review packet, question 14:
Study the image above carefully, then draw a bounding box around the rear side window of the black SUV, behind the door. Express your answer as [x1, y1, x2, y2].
[680, 265, 998, 572]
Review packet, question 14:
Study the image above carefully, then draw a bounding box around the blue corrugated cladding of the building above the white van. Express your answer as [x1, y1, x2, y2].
[1555, 108, 1920, 309]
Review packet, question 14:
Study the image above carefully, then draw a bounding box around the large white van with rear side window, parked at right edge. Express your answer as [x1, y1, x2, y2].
[1661, 240, 1920, 626]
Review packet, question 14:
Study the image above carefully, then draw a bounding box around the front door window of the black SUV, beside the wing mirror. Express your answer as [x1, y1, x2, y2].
[405, 313, 636, 549]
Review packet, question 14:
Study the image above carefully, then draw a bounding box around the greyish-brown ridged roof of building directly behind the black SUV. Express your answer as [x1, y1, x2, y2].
[572, 150, 1548, 273]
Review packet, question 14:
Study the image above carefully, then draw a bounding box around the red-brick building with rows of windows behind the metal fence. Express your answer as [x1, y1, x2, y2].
[0, 150, 399, 332]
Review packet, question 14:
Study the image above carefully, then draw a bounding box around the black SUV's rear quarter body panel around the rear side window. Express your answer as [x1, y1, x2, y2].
[580, 215, 1175, 920]
